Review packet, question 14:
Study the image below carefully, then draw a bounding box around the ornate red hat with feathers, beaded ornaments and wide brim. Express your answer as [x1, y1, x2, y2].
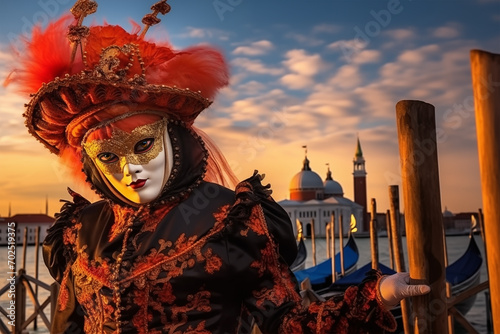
[11, 0, 228, 154]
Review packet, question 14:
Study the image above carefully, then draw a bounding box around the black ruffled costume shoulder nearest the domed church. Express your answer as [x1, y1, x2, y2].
[227, 171, 297, 265]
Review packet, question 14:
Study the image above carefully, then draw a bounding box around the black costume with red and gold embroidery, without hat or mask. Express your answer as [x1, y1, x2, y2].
[44, 124, 395, 334]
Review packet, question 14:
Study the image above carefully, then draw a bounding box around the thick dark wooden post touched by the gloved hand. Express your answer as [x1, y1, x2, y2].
[396, 100, 448, 334]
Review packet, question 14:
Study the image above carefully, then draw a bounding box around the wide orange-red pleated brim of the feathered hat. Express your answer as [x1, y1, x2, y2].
[24, 72, 212, 154]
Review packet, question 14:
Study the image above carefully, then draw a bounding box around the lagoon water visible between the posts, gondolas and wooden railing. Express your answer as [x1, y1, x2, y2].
[0, 236, 487, 334]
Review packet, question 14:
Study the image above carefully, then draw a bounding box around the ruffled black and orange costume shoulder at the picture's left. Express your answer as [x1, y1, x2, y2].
[43, 189, 90, 282]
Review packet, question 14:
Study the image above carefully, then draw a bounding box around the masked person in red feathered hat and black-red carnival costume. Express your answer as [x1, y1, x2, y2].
[5, 0, 429, 334]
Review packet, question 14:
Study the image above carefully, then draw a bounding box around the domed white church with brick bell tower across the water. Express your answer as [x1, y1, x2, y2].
[278, 139, 366, 237]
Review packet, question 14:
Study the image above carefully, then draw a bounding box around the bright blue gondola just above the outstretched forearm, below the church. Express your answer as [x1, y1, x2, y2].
[294, 233, 359, 291]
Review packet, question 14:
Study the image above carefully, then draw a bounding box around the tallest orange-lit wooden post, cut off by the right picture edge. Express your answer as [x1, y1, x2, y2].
[470, 50, 500, 332]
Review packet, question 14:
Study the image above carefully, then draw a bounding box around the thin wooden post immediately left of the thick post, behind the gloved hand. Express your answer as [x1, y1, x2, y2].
[389, 185, 412, 333]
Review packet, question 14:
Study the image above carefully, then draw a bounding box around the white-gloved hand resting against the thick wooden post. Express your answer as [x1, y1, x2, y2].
[378, 273, 431, 309]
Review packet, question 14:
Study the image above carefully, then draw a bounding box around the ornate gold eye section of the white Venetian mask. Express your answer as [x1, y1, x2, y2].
[83, 120, 166, 175]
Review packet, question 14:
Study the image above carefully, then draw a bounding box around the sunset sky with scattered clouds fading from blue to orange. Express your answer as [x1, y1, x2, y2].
[0, 0, 500, 217]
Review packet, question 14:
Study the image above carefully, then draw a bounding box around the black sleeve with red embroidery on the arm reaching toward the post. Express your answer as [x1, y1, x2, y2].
[228, 173, 396, 334]
